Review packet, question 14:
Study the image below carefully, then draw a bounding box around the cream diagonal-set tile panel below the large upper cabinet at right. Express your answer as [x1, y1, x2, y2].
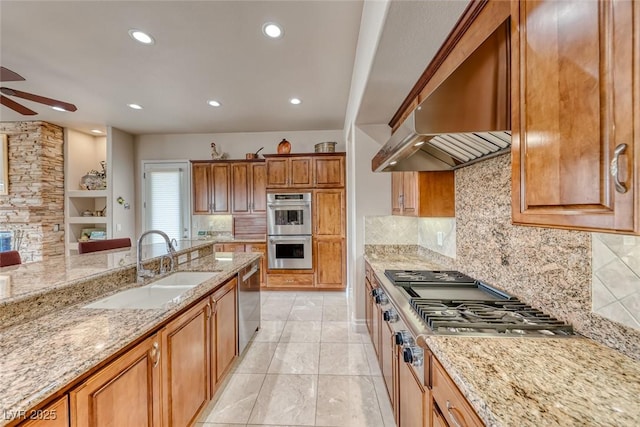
[591, 233, 640, 329]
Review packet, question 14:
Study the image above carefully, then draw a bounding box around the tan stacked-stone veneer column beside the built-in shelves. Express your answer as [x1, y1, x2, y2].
[0, 121, 64, 262]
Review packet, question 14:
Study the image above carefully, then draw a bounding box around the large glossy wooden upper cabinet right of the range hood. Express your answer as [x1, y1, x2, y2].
[512, 0, 640, 233]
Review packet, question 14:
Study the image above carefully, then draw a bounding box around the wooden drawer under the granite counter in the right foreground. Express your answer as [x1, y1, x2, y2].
[431, 358, 484, 427]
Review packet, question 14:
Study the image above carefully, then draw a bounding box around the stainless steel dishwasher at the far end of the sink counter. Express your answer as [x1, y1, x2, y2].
[238, 260, 260, 354]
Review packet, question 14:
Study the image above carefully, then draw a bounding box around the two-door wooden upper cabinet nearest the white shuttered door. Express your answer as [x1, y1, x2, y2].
[192, 163, 231, 215]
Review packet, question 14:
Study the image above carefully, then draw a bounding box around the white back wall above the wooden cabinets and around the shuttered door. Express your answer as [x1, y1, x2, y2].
[134, 129, 346, 234]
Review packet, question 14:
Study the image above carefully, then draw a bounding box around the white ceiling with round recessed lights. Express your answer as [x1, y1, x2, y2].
[0, 0, 468, 134]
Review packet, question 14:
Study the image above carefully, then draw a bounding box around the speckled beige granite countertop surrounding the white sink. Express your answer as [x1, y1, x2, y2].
[0, 253, 260, 425]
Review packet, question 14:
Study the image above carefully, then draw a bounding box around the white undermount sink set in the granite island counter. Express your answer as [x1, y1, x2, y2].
[83, 271, 218, 309]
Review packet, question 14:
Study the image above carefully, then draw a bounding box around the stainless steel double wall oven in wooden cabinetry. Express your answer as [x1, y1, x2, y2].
[267, 192, 313, 270]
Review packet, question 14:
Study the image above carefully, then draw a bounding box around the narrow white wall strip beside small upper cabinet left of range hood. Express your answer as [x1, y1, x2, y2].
[347, 125, 391, 320]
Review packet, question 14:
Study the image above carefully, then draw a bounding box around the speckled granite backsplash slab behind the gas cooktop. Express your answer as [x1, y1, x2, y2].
[456, 155, 640, 359]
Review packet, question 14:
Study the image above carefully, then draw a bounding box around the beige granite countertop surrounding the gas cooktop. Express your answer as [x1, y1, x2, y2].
[365, 254, 640, 427]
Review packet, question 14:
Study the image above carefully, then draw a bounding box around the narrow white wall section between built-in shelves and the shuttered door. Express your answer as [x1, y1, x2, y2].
[107, 127, 137, 242]
